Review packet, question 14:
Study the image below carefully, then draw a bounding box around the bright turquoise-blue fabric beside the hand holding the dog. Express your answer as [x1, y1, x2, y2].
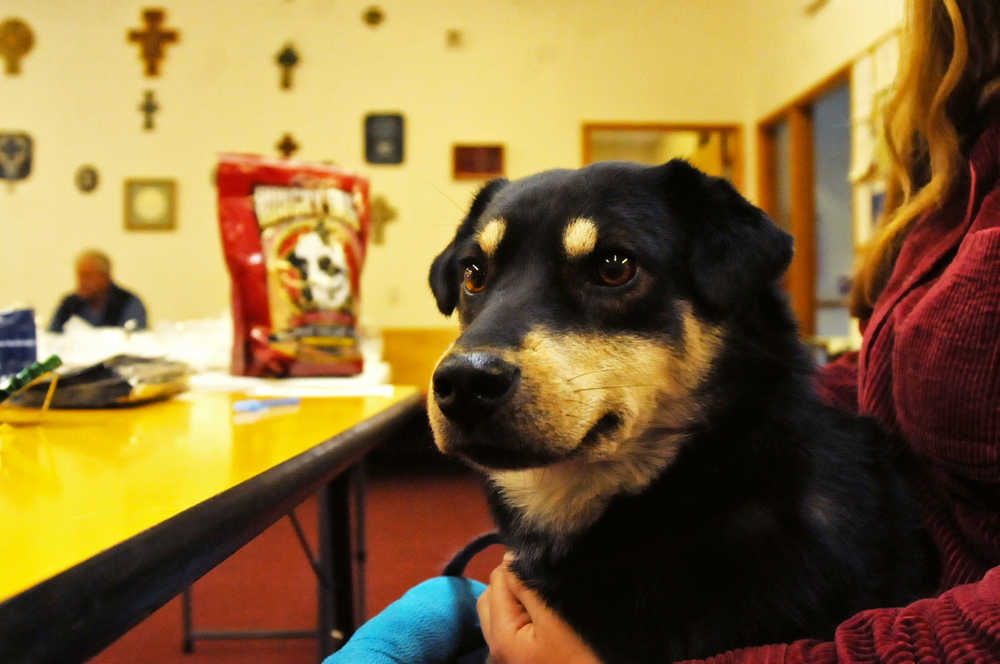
[323, 576, 486, 664]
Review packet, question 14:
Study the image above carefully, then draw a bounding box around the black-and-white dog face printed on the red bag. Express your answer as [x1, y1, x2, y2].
[288, 231, 351, 309]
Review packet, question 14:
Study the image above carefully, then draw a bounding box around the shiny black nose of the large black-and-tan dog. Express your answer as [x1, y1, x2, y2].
[433, 352, 521, 425]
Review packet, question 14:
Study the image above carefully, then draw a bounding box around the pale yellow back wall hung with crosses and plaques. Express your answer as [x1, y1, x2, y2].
[0, 0, 752, 326]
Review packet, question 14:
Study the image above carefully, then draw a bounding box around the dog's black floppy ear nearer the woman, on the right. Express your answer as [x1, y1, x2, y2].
[659, 159, 792, 312]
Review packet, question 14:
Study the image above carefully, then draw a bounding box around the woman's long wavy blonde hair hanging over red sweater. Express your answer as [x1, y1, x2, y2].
[849, 0, 1000, 318]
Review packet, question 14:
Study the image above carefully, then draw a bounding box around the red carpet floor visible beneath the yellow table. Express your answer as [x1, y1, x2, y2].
[90, 471, 502, 664]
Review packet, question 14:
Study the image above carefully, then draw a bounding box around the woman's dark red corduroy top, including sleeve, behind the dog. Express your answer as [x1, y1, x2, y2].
[712, 123, 1000, 664]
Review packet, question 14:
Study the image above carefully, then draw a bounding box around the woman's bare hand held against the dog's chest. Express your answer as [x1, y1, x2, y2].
[476, 554, 601, 664]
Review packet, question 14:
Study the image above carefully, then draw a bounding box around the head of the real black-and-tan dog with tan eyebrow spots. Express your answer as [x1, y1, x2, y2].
[428, 161, 791, 528]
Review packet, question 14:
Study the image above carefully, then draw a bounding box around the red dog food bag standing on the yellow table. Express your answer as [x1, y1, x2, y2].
[218, 154, 370, 376]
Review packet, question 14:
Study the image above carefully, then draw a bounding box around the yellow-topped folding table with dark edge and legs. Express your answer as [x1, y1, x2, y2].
[0, 387, 423, 663]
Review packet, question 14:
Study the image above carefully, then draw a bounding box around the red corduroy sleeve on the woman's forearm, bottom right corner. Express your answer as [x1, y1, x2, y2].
[705, 567, 1000, 664]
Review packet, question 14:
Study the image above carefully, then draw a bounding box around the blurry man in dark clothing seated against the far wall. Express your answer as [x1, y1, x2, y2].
[49, 249, 146, 332]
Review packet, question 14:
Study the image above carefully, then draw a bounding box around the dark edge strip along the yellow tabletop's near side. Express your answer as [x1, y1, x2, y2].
[0, 392, 425, 663]
